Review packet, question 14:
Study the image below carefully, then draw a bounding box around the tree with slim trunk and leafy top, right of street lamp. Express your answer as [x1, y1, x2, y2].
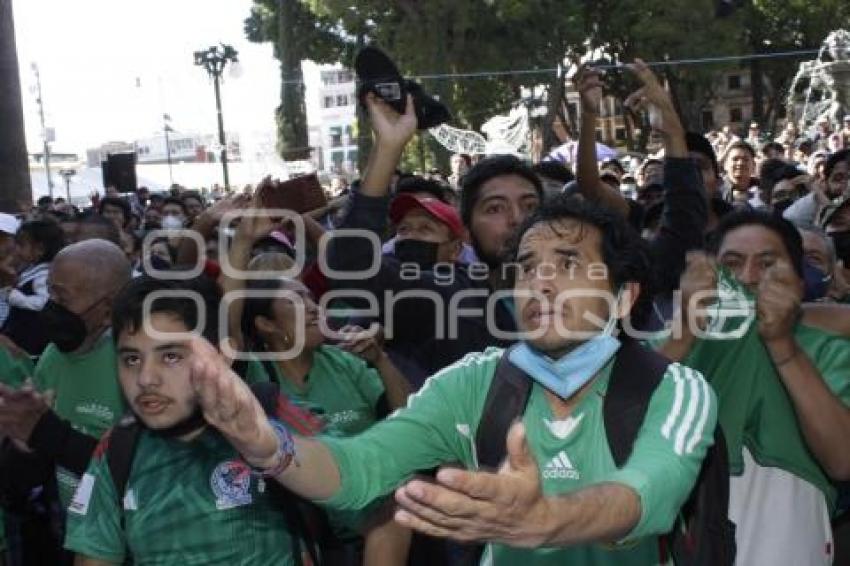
[245, 0, 343, 161]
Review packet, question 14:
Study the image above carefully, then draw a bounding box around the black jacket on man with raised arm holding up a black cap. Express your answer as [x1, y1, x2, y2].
[327, 192, 516, 384]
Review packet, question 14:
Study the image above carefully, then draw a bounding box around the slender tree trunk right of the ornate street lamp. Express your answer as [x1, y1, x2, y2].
[276, 0, 310, 161]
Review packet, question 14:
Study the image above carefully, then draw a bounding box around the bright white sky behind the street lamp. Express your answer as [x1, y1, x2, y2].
[12, 0, 312, 155]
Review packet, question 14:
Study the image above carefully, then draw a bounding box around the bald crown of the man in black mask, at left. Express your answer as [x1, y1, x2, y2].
[51, 239, 130, 294]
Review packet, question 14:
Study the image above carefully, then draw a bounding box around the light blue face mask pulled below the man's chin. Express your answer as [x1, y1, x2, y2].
[508, 296, 620, 401]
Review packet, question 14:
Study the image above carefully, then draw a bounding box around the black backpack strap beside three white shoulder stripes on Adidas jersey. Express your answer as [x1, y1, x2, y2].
[602, 338, 670, 468]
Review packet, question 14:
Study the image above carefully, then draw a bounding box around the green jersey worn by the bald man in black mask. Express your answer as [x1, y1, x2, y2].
[34, 333, 126, 506]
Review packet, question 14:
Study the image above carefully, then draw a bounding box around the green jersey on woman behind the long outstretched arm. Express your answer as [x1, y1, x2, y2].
[270, 346, 384, 436]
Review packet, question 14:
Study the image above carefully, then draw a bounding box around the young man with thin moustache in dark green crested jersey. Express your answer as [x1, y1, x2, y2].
[66, 277, 319, 566]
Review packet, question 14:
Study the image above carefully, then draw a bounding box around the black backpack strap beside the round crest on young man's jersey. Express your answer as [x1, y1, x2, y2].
[251, 382, 321, 566]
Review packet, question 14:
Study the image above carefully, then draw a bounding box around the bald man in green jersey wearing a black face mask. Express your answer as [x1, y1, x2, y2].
[0, 240, 130, 510]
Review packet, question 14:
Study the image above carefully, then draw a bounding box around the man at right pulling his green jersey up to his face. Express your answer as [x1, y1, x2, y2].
[663, 211, 850, 566]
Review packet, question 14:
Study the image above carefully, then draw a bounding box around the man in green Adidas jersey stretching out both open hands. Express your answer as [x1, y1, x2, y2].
[184, 198, 716, 565]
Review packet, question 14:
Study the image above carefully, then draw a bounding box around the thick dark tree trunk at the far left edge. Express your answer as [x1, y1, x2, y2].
[0, 0, 32, 212]
